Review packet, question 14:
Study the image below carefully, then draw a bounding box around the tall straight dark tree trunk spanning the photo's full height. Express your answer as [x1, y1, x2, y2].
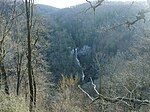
[25, 0, 34, 112]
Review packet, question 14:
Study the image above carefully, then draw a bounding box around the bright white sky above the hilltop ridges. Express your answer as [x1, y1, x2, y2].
[35, 0, 146, 8]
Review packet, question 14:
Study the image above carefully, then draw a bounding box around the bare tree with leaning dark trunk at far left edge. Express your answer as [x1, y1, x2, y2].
[0, 0, 16, 94]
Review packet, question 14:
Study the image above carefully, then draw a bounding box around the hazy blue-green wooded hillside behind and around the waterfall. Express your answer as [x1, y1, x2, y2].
[44, 2, 148, 81]
